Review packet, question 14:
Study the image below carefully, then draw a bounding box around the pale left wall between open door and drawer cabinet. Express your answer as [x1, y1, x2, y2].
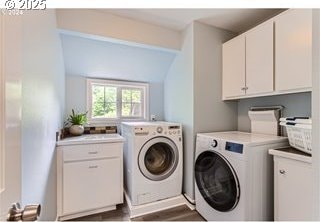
[21, 9, 65, 220]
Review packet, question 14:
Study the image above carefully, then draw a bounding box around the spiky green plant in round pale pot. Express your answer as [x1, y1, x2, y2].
[67, 109, 88, 136]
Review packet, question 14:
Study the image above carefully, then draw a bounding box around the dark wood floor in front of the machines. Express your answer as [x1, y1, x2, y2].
[73, 204, 205, 221]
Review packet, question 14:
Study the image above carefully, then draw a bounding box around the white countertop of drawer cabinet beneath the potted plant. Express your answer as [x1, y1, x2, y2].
[56, 133, 125, 146]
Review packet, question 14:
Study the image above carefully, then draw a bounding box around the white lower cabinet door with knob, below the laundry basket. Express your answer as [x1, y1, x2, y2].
[274, 159, 312, 221]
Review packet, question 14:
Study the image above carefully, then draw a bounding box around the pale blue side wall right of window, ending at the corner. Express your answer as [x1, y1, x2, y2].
[164, 25, 194, 198]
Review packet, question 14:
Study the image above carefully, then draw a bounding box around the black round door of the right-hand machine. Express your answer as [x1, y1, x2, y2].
[195, 151, 240, 212]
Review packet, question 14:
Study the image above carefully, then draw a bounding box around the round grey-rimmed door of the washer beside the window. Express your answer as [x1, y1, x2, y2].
[138, 137, 179, 181]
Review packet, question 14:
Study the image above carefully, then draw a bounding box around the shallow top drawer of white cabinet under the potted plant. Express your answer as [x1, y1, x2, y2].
[63, 143, 123, 162]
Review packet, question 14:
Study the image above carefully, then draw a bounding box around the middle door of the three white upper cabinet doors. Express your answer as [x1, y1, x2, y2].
[246, 21, 273, 95]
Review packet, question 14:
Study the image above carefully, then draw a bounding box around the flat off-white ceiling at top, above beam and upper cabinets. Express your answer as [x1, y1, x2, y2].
[99, 8, 285, 33]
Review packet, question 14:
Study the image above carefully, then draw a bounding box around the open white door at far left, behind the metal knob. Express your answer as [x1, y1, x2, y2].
[0, 14, 22, 221]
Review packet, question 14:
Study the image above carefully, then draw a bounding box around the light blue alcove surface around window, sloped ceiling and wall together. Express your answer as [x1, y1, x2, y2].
[61, 35, 176, 120]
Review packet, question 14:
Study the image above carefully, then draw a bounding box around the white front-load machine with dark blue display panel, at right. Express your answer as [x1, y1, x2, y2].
[195, 131, 288, 221]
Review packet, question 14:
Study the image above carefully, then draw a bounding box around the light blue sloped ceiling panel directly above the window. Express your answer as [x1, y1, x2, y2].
[61, 34, 175, 82]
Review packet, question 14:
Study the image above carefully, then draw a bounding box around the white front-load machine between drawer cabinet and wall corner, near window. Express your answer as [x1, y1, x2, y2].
[121, 122, 183, 206]
